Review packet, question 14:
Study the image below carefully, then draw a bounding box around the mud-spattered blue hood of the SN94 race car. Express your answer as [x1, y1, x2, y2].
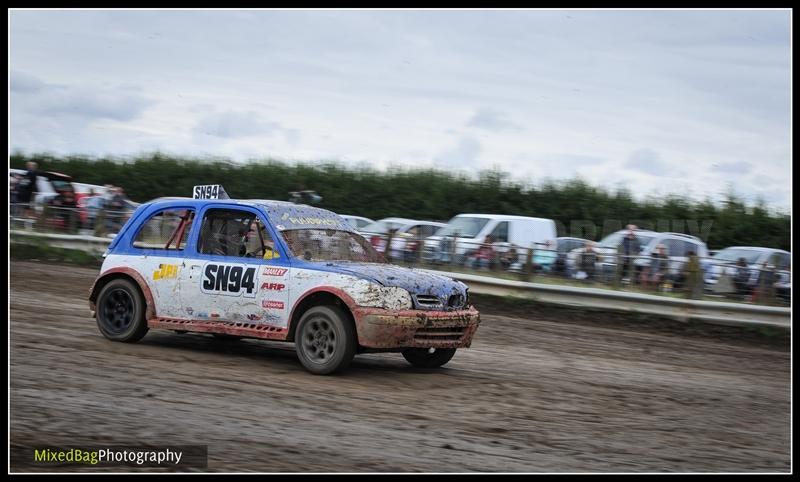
[325, 261, 467, 297]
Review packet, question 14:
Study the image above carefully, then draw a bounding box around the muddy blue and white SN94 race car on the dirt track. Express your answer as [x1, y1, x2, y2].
[89, 187, 480, 375]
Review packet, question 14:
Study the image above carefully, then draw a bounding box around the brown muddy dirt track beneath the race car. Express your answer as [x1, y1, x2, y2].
[9, 262, 790, 472]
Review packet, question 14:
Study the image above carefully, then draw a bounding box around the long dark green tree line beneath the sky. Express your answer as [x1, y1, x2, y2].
[10, 153, 791, 250]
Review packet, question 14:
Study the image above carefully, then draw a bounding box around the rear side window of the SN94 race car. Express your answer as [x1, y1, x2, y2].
[133, 209, 194, 251]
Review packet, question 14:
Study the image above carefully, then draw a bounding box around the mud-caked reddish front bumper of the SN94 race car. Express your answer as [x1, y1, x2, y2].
[353, 306, 481, 349]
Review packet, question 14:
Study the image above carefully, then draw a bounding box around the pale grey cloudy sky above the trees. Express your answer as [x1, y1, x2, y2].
[9, 10, 791, 211]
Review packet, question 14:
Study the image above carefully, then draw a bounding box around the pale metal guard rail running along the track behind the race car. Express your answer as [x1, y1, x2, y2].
[9, 230, 791, 329]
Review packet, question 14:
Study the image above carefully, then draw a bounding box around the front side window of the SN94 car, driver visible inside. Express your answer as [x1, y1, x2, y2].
[197, 209, 280, 259]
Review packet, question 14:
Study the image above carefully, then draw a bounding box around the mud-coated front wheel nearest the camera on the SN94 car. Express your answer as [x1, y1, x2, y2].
[294, 306, 358, 375]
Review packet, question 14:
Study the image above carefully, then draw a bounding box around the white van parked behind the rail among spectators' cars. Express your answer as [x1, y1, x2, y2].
[425, 214, 557, 261]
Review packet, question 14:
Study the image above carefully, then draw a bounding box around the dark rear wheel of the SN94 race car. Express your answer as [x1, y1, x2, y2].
[95, 279, 147, 343]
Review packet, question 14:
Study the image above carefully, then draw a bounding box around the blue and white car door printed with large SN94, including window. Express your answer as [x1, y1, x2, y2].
[184, 204, 291, 327]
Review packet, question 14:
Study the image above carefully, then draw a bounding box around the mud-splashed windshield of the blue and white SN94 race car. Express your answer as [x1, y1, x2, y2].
[281, 229, 386, 263]
